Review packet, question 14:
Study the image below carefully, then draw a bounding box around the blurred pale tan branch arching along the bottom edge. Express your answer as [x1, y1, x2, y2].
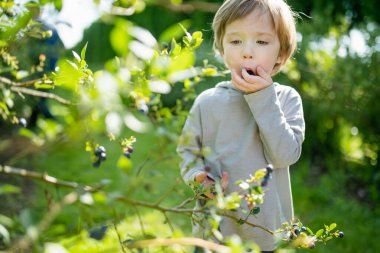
[126, 237, 232, 253]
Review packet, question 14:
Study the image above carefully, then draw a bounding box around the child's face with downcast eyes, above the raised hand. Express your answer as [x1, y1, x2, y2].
[222, 9, 281, 75]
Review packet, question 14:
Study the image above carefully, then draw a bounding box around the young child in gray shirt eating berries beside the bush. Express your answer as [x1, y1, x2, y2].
[177, 0, 305, 251]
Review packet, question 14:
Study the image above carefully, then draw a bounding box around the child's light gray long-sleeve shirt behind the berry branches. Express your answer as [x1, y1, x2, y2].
[177, 81, 305, 250]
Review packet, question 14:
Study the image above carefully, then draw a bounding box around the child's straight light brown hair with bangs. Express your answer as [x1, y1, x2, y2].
[212, 0, 297, 73]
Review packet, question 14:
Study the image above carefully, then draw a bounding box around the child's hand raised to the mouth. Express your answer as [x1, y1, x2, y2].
[231, 66, 273, 93]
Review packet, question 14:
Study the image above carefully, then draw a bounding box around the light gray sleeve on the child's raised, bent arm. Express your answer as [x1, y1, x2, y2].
[244, 84, 305, 168]
